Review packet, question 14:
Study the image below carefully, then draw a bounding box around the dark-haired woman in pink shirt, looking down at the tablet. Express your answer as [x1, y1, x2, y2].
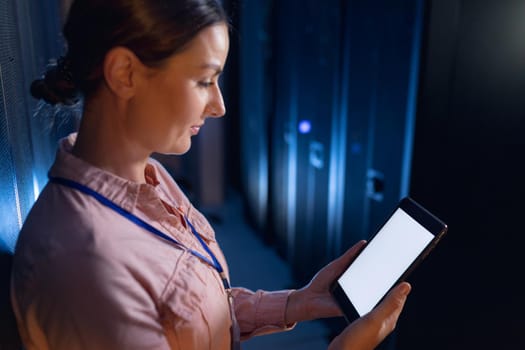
[12, 0, 410, 349]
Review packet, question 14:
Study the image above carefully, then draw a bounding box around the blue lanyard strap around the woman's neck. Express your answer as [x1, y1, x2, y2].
[49, 176, 230, 290]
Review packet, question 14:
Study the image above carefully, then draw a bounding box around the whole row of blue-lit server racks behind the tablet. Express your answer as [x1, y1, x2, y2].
[260, 0, 423, 281]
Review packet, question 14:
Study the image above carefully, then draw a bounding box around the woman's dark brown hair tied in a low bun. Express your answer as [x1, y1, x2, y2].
[31, 0, 228, 105]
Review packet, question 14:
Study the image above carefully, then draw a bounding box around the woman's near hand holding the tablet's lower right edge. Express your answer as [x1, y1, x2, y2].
[328, 282, 411, 350]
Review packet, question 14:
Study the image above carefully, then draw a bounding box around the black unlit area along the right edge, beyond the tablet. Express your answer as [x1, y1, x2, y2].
[399, 1, 525, 349]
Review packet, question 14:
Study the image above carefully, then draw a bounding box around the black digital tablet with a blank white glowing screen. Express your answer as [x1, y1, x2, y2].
[331, 197, 447, 322]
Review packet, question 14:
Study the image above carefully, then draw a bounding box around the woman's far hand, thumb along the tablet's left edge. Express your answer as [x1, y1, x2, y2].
[285, 241, 365, 324]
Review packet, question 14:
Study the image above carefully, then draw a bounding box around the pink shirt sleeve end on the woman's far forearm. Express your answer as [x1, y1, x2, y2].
[232, 288, 295, 340]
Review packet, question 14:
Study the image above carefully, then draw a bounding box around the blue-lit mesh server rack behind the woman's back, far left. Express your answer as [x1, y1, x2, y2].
[0, 0, 63, 349]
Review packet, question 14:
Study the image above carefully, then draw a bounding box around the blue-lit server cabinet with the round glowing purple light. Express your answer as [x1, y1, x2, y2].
[270, 1, 341, 282]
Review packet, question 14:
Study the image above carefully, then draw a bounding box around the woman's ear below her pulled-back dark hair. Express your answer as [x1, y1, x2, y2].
[104, 47, 144, 99]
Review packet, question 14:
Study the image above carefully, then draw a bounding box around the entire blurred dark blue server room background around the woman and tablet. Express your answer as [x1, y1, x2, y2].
[0, 0, 525, 350]
